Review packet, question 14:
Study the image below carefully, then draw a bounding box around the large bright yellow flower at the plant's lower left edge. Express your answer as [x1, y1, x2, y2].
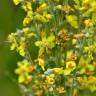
[15, 60, 34, 84]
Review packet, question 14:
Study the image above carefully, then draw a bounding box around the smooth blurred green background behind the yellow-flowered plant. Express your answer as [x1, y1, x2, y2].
[0, 0, 96, 96]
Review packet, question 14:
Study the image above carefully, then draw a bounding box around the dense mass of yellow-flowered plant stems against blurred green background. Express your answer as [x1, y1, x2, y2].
[8, 0, 96, 96]
